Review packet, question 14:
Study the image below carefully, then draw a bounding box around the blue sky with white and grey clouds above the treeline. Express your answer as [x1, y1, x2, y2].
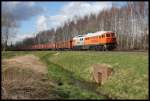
[2, 2, 123, 42]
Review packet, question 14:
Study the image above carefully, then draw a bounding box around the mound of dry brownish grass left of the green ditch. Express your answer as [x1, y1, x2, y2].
[2, 55, 57, 99]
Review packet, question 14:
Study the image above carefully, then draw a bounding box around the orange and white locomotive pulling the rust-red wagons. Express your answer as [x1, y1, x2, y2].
[73, 31, 117, 50]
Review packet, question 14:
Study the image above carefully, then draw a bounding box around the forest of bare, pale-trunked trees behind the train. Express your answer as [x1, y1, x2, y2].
[2, 2, 149, 50]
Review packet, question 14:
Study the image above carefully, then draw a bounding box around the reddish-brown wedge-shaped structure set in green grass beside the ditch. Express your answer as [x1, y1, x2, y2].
[92, 64, 113, 85]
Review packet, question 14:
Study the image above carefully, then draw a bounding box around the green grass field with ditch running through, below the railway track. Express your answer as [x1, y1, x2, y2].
[2, 51, 148, 99]
